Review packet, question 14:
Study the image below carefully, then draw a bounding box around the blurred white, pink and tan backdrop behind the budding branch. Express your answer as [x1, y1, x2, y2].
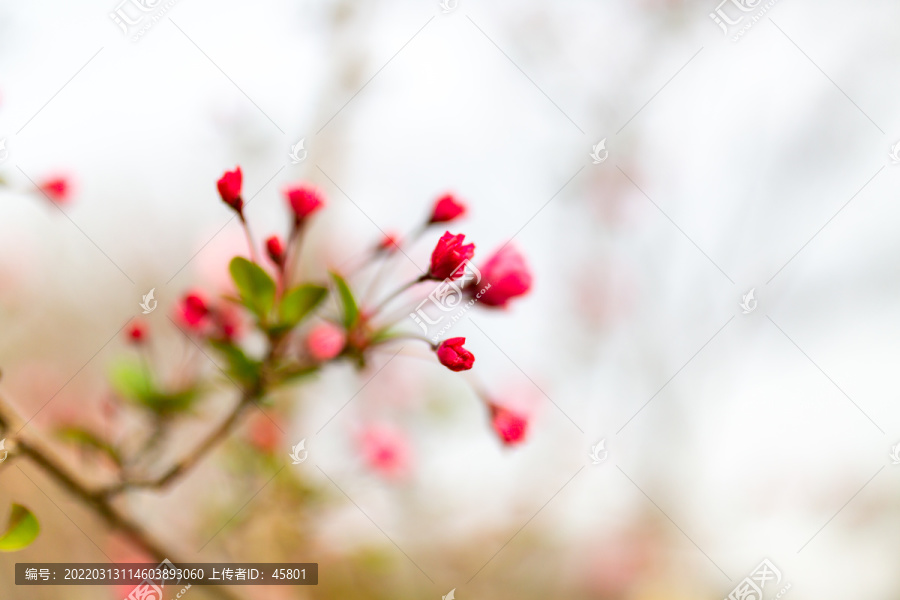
[0, 0, 900, 600]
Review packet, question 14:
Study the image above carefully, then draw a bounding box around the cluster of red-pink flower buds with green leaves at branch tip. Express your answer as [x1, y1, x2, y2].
[127, 167, 532, 460]
